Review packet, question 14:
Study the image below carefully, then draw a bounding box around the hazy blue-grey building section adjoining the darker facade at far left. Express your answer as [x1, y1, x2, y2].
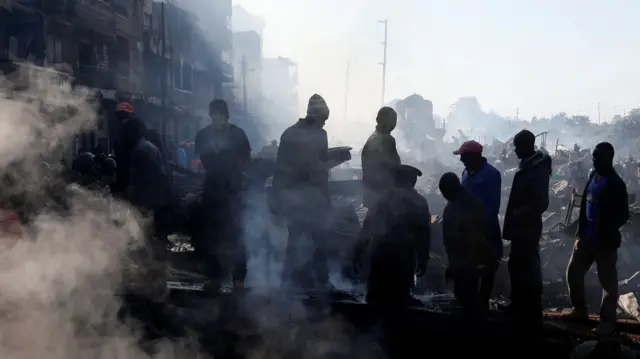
[143, 1, 233, 142]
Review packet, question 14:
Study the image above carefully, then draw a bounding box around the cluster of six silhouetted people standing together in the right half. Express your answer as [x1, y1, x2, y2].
[356, 107, 629, 335]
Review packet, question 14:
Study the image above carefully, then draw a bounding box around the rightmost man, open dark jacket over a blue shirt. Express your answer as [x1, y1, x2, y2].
[567, 142, 629, 335]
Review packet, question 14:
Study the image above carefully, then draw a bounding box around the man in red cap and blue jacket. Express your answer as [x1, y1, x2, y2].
[453, 140, 503, 308]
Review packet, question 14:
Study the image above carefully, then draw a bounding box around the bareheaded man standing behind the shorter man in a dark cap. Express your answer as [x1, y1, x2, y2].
[362, 107, 400, 207]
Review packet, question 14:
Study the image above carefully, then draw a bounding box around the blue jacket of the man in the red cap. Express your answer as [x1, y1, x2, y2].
[462, 159, 503, 258]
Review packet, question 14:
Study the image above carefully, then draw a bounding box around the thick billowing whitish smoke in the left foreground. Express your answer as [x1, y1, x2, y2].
[0, 67, 188, 359]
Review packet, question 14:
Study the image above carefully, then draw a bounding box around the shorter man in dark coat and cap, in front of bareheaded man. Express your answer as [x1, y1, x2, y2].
[355, 165, 431, 309]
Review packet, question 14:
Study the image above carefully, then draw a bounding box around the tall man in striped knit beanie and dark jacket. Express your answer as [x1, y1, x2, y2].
[272, 94, 331, 288]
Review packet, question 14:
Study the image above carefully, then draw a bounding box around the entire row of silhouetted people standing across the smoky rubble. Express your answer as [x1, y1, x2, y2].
[107, 94, 629, 333]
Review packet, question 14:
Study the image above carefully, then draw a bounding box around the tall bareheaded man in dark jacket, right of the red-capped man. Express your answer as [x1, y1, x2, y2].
[502, 130, 551, 333]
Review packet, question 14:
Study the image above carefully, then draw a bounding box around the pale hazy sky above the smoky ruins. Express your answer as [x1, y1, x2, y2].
[234, 0, 640, 125]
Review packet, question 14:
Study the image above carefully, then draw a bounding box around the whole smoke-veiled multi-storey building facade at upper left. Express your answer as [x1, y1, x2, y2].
[0, 0, 242, 151]
